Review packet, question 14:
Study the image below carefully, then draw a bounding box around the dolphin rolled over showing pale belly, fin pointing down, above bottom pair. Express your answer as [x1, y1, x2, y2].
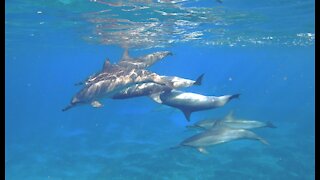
[150, 89, 240, 121]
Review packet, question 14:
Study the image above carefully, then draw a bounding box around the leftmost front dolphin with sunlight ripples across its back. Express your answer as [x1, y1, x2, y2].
[63, 59, 173, 111]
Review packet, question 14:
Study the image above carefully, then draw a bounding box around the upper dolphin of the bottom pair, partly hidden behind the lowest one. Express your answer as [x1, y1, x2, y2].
[187, 111, 276, 129]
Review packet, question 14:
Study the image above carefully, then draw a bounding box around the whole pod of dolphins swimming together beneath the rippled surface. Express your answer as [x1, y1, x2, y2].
[62, 49, 275, 153]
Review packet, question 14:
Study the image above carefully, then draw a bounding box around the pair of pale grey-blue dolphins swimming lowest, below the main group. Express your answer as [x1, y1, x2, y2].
[171, 111, 276, 154]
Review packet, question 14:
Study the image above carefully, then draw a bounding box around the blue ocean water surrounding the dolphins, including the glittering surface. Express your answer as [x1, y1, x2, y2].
[5, 0, 315, 180]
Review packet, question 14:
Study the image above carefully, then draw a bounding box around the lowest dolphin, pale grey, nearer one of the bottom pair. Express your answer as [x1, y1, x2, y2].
[172, 125, 269, 153]
